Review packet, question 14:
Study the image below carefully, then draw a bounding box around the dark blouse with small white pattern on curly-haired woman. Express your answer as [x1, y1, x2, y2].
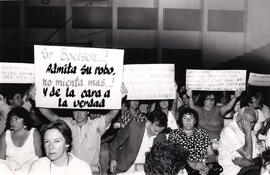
[168, 128, 210, 162]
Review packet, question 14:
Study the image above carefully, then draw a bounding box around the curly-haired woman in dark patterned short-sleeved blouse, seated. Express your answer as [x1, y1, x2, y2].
[168, 108, 220, 175]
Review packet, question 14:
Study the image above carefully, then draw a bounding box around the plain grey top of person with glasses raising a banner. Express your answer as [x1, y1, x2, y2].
[197, 106, 224, 140]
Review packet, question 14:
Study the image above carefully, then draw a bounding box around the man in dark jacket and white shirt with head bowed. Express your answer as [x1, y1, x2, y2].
[110, 111, 168, 174]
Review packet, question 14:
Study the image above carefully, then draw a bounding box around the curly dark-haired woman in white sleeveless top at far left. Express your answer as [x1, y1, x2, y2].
[0, 107, 42, 174]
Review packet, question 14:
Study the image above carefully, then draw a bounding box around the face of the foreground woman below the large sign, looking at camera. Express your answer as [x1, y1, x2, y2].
[43, 129, 68, 161]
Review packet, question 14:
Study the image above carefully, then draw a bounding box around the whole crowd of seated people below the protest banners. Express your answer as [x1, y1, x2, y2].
[0, 82, 270, 175]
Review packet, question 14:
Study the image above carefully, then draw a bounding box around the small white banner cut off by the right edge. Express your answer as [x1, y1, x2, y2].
[248, 73, 270, 86]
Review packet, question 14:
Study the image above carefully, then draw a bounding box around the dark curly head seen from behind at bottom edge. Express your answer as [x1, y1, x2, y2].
[144, 141, 189, 175]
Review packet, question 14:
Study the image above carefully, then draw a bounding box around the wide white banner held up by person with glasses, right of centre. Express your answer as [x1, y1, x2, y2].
[186, 69, 246, 91]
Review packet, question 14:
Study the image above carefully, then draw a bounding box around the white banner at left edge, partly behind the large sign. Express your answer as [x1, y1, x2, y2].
[0, 62, 35, 84]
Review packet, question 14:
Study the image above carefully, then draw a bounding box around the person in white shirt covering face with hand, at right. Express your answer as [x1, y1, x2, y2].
[218, 107, 259, 175]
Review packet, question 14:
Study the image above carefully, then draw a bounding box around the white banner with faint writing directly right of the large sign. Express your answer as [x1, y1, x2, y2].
[123, 64, 176, 100]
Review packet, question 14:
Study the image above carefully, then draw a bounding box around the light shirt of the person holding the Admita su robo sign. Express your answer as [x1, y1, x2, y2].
[61, 115, 109, 169]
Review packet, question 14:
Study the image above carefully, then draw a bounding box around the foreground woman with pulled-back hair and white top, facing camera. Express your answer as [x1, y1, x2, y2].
[29, 120, 92, 175]
